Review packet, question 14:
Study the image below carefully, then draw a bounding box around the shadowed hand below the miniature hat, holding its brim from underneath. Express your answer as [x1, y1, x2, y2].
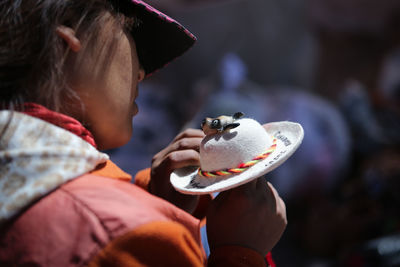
[207, 177, 287, 256]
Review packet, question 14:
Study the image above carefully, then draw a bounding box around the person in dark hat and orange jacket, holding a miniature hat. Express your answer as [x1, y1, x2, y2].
[0, 0, 286, 266]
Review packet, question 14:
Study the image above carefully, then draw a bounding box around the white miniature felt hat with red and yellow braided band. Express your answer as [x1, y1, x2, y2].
[170, 118, 304, 195]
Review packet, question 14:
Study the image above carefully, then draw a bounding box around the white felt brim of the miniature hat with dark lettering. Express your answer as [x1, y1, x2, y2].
[170, 121, 304, 195]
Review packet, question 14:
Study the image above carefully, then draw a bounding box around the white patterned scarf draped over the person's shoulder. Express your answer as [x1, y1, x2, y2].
[0, 110, 108, 225]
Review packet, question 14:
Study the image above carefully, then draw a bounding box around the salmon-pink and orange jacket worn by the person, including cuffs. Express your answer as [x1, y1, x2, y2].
[0, 161, 266, 267]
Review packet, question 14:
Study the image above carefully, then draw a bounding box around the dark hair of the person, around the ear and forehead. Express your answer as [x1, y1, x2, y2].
[0, 0, 135, 111]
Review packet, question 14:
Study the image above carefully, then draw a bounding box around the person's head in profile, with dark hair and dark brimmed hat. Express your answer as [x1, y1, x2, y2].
[0, 0, 195, 148]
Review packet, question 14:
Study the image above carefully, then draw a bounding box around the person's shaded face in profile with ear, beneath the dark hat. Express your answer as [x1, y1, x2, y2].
[56, 9, 145, 149]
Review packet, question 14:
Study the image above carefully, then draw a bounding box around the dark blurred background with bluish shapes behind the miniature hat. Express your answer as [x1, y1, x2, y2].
[109, 0, 400, 266]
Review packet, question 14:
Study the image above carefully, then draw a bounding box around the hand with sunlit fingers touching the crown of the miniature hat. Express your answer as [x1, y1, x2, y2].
[149, 129, 204, 213]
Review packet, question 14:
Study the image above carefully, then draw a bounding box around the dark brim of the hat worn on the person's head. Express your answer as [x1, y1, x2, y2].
[114, 0, 196, 76]
